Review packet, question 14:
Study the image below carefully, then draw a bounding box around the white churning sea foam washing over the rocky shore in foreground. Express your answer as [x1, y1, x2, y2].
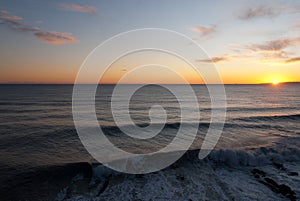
[58, 137, 300, 201]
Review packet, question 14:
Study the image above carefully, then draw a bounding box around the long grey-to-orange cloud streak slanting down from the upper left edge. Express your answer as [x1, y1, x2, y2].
[0, 10, 79, 45]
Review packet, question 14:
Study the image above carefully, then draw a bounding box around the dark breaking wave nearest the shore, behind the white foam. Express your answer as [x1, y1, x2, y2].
[1, 135, 294, 200]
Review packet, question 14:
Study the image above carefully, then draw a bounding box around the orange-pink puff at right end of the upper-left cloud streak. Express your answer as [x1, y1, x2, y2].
[34, 31, 79, 45]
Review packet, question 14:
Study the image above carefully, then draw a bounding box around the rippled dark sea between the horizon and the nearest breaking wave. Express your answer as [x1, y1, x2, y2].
[0, 84, 300, 197]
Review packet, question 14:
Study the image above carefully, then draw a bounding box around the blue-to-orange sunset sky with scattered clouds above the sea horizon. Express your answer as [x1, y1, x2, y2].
[0, 0, 300, 84]
